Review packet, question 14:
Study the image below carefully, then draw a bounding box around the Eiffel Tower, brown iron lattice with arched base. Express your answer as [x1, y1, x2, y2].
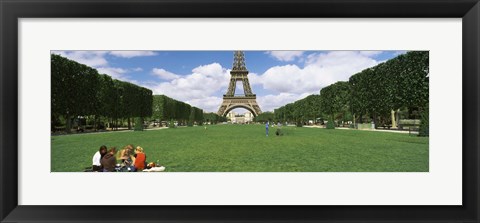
[217, 51, 262, 117]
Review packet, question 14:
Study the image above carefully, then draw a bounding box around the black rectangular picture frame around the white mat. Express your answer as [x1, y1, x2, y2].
[0, 0, 480, 222]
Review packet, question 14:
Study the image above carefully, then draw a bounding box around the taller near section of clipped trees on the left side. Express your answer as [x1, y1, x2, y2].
[50, 54, 152, 132]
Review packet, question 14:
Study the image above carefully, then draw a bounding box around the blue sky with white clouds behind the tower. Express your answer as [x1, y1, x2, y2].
[52, 51, 405, 113]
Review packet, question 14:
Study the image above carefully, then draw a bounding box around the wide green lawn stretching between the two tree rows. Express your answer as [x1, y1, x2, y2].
[51, 125, 429, 172]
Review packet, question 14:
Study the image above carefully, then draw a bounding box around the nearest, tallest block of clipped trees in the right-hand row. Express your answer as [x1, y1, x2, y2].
[349, 51, 429, 126]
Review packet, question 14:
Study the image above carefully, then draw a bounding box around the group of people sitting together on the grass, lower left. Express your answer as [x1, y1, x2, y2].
[92, 145, 156, 172]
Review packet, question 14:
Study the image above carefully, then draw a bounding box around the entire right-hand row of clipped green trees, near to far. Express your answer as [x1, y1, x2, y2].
[274, 51, 429, 133]
